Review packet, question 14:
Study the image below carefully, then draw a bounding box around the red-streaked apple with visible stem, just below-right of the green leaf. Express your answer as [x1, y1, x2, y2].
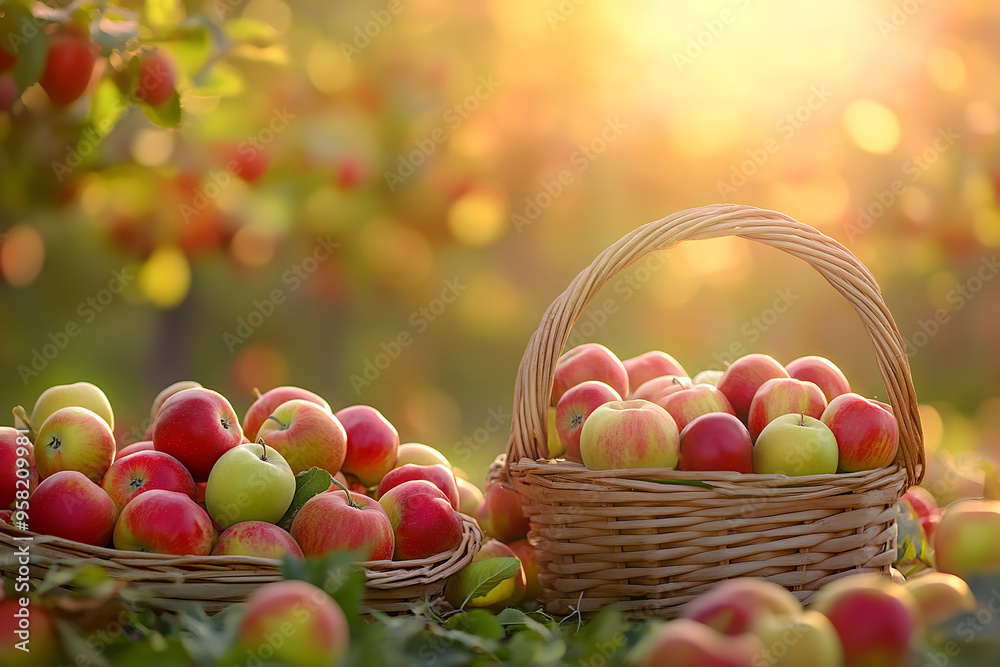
[289, 488, 395, 560]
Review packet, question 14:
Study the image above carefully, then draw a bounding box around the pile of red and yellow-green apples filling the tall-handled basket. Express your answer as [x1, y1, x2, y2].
[548, 343, 899, 476]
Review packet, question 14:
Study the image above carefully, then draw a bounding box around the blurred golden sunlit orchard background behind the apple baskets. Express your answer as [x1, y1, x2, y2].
[0, 0, 1000, 490]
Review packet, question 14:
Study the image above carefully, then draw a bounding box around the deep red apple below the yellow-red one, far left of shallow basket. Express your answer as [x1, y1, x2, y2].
[28, 470, 118, 547]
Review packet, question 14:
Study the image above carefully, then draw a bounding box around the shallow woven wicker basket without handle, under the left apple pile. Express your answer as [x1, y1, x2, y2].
[0, 514, 482, 613]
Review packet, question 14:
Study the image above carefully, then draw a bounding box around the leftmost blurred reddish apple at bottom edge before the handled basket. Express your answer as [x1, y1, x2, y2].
[635, 618, 767, 667]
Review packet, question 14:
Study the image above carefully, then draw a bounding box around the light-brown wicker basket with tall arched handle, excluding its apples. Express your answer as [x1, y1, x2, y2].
[504, 205, 924, 618]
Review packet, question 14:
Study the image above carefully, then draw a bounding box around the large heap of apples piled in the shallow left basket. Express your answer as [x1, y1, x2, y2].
[0, 381, 483, 560]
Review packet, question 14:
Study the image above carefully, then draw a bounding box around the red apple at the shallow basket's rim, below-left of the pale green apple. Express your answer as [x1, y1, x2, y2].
[114, 489, 212, 556]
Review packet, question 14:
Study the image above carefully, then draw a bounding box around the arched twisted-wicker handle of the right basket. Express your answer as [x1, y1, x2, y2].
[506, 204, 924, 485]
